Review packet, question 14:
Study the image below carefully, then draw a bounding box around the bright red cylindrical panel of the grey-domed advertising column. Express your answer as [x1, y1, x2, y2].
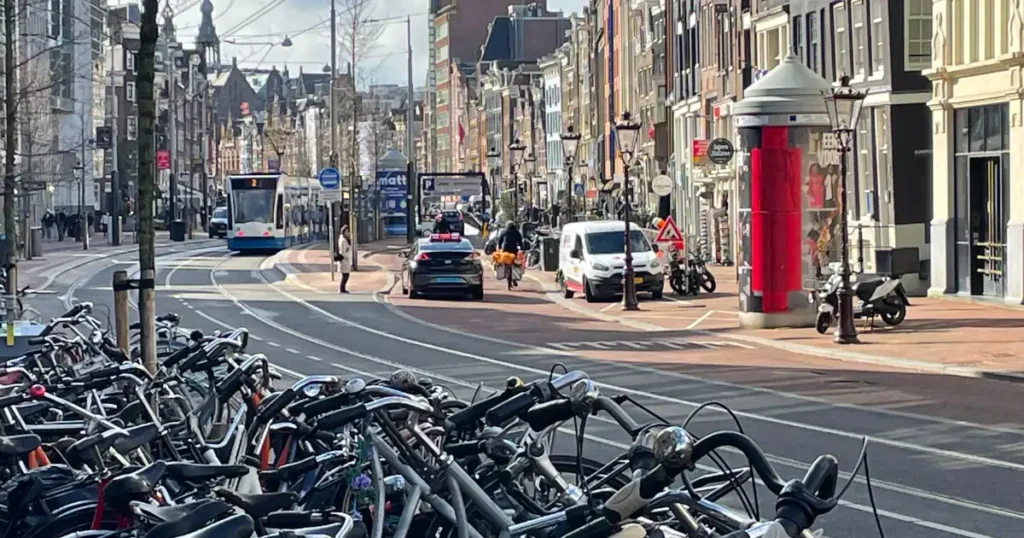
[750, 126, 803, 314]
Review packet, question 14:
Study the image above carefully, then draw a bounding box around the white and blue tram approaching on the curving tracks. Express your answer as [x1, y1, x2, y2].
[225, 173, 322, 252]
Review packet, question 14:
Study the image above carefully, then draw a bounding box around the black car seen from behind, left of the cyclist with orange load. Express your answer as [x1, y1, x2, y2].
[401, 234, 483, 300]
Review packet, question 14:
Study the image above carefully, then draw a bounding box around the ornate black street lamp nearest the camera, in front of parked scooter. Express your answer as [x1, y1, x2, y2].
[822, 75, 865, 344]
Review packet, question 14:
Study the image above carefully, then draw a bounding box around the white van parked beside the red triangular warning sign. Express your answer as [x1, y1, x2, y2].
[558, 220, 665, 302]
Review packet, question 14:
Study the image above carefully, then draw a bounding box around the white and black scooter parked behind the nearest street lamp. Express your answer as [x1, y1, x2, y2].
[808, 274, 910, 334]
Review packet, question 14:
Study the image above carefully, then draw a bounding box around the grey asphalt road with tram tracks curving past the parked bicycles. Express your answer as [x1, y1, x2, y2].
[46, 241, 1024, 538]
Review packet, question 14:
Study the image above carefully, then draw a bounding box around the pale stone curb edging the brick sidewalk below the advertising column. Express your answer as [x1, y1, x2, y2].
[526, 275, 1024, 383]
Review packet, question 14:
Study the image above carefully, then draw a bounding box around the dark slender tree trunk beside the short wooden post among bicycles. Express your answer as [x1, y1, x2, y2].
[136, 0, 160, 373]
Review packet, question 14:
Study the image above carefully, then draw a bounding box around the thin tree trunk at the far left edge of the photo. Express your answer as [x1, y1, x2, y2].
[3, 0, 17, 332]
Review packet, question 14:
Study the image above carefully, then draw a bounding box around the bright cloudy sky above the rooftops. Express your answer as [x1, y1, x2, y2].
[174, 0, 586, 86]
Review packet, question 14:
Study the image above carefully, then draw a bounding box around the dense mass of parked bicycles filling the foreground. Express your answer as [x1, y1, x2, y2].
[0, 303, 884, 538]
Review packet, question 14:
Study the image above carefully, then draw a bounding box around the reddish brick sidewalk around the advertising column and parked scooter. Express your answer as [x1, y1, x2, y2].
[532, 266, 1024, 381]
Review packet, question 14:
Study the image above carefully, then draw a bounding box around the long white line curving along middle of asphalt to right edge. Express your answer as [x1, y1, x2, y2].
[261, 266, 1024, 471]
